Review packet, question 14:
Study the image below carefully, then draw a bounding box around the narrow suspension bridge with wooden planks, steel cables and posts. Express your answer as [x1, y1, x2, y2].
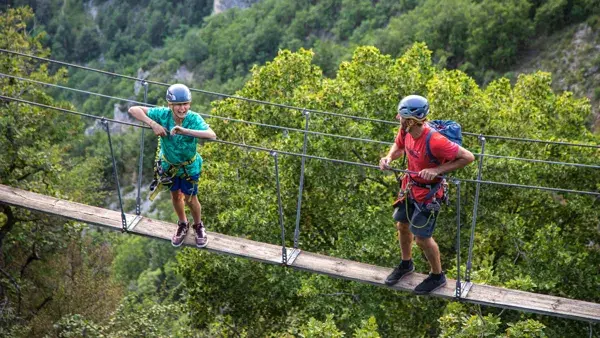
[0, 49, 600, 325]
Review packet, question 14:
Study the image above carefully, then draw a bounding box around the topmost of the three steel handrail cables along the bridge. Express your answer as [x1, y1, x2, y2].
[0, 48, 600, 149]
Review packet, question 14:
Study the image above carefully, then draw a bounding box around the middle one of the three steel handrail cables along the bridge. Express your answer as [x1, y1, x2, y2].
[0, 72, 600, 169]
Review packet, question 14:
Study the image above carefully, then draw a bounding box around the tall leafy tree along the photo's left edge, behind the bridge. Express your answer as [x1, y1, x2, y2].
[0, 8, 120, 336]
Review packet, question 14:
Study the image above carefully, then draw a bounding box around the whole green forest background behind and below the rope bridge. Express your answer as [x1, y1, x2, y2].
[0, 0, 600, 337]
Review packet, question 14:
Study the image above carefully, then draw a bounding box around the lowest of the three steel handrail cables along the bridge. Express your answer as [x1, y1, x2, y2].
[0, 95, 600, 197]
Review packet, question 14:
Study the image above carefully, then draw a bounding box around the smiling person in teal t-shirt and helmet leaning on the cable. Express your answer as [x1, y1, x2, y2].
[129, 84, 217, 248]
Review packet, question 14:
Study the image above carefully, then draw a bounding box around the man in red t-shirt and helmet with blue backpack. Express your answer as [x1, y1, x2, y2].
[379, 95, 475, 294]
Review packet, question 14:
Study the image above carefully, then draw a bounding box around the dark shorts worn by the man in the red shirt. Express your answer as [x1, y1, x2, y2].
[393, 198, 439, 238]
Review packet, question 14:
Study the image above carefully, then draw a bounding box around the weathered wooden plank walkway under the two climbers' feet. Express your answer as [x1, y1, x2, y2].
[0, 185, 600, 322]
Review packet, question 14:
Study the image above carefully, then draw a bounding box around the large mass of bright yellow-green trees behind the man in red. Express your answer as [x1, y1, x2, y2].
[180, 44, 600, 337]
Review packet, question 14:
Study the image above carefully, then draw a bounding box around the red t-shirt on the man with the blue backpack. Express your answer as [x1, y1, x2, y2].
[396, 124, 458, 203]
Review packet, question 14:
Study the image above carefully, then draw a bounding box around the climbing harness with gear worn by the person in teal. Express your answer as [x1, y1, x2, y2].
[149, 138, 198, 201]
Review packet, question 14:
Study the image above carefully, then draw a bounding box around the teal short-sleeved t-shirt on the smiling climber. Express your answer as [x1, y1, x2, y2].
[148, 107, 209, 176]
